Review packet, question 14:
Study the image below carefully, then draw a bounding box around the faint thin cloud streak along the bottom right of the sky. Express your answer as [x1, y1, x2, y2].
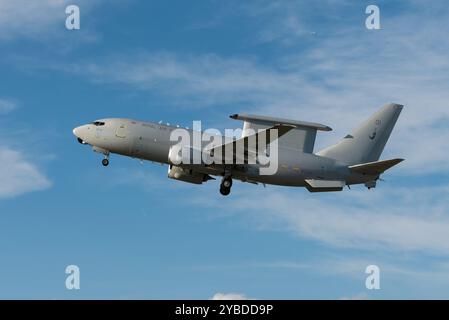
[200, 254, 449, 300]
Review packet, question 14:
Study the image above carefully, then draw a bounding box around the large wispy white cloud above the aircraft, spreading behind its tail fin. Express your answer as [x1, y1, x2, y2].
[64, 2, 449, 175]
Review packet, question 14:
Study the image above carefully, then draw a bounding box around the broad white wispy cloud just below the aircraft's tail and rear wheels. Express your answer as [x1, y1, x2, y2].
[198, 185, 449, 255]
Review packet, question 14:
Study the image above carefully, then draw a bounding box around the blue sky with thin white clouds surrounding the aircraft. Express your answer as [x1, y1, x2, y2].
[0, 0, 449, 299]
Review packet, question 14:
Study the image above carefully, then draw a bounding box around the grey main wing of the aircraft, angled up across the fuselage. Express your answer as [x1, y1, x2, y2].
[207, 124, 296, 160]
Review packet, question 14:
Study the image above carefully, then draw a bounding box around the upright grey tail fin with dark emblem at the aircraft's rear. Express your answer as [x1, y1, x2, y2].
[317, 103, 403, 165]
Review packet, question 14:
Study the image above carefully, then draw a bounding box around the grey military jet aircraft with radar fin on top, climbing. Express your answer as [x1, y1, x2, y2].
[73, 103, 403, 195]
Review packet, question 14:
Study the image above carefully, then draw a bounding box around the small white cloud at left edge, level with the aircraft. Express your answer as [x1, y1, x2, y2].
[0, 146, 51, 198]
